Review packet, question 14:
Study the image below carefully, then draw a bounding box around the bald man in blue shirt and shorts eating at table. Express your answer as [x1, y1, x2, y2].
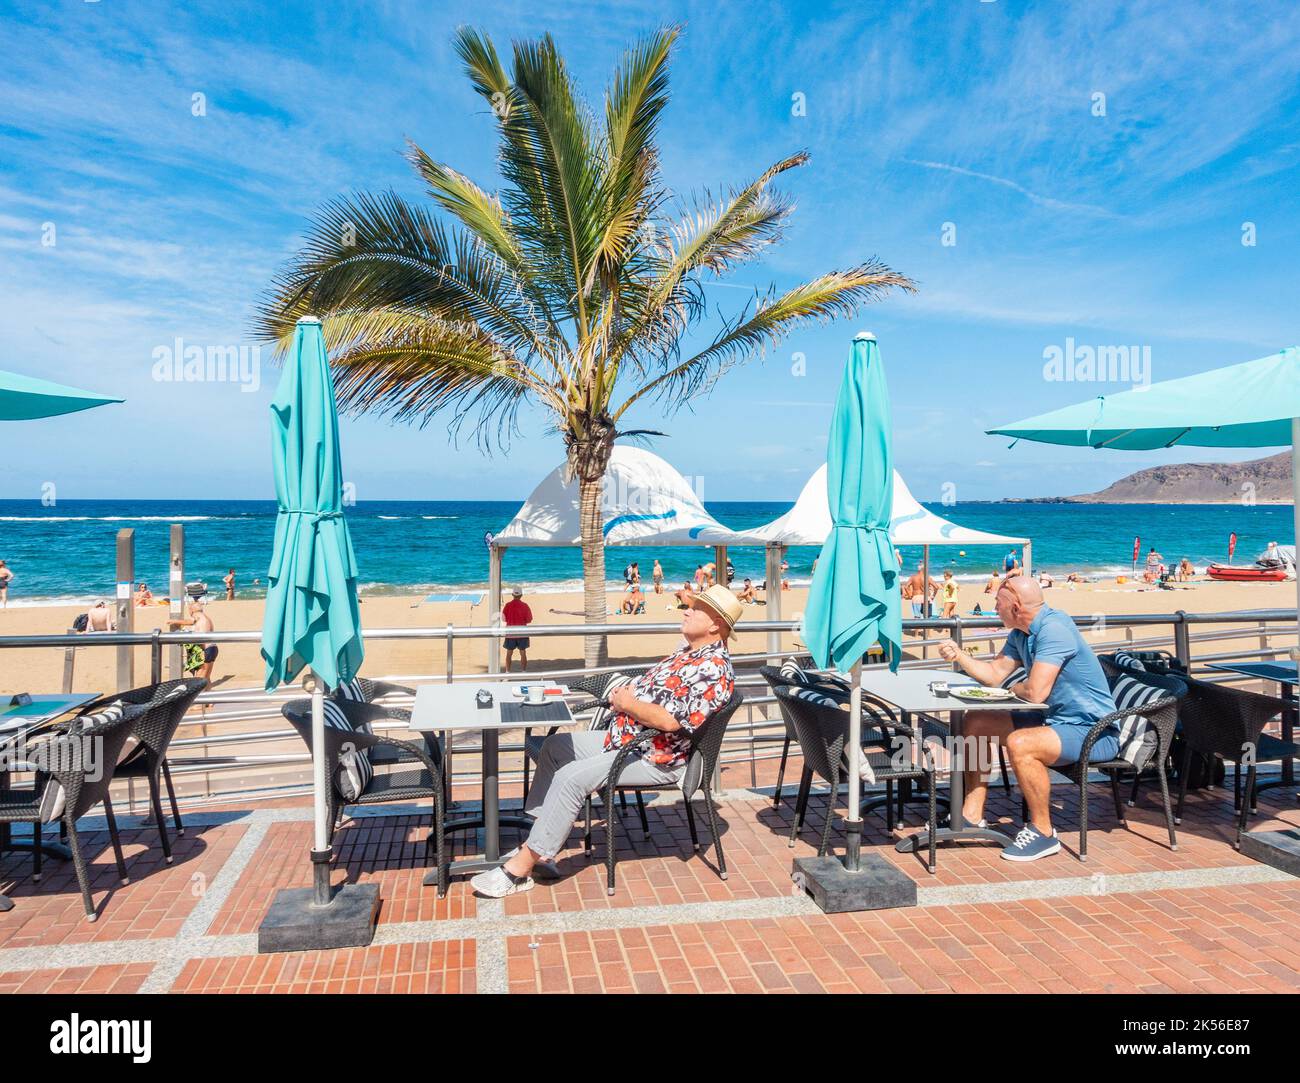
[939, 576, 1119, 861]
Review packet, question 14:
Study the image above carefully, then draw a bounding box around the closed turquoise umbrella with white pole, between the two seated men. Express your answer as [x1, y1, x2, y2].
[803, 332, 902, 872]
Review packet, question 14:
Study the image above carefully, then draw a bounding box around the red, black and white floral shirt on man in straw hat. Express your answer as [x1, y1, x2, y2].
[605, 641, 736, 768]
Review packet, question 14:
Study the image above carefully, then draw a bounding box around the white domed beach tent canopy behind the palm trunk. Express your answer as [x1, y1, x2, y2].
[493, 445, 764, 549]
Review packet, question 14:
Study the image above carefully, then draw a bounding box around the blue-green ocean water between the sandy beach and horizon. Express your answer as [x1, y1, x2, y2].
[0, 499, 1294, 606]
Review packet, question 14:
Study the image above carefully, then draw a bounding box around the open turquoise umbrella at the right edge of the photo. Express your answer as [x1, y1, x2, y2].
[988, 346, 1300, 650]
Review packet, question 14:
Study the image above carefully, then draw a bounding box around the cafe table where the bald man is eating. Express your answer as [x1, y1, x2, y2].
[862, 667, 1048, 853]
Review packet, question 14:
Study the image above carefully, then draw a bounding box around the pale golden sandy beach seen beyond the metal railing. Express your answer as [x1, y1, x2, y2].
[0, 579, 1296, 692]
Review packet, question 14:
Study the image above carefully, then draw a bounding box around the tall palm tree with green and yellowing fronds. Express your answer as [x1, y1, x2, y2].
[257, 27, 913, 664]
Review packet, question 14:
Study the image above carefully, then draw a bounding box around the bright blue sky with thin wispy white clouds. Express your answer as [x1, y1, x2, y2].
[0, 0, 1300, 499]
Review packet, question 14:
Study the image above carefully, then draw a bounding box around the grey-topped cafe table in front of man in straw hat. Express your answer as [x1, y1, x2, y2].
[410, 680, 573, 887]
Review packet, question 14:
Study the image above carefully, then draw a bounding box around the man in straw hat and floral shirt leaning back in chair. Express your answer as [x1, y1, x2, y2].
[469, 586, 741, 898]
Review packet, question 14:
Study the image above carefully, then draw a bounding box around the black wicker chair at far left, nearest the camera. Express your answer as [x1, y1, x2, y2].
[0, 703, 148, 922]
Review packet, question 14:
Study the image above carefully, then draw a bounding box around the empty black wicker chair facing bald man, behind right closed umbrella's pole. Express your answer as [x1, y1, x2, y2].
[775, 688, 939, 872]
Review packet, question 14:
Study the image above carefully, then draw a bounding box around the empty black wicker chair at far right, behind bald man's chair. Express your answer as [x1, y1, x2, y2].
[1174, 677, 1300, 849]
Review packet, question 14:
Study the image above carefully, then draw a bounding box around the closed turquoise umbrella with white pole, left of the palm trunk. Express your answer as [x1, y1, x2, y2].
[261, 316, 364, 946]
